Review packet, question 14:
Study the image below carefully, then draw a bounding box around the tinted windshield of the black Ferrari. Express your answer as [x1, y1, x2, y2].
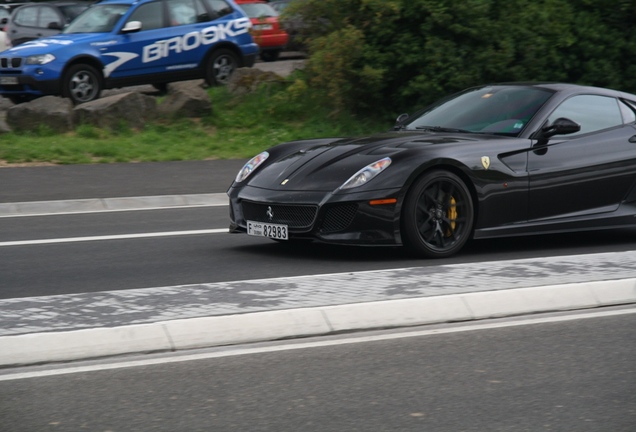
[404, 86, 553, 136]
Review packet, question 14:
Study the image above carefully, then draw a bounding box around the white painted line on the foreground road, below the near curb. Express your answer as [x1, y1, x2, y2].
[0, 308, 636, 381]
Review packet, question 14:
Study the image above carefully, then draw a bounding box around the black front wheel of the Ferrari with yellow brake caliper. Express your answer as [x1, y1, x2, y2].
[401, 170, 475, 258]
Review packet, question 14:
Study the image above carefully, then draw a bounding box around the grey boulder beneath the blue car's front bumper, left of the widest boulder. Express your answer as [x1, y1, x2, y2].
[6, 96, 73, 132]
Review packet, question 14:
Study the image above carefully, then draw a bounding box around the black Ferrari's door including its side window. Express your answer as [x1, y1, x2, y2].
[528, 95, 636, 220]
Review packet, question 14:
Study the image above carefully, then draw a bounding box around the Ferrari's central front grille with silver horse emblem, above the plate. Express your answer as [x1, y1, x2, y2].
[241, 201, 317, 228]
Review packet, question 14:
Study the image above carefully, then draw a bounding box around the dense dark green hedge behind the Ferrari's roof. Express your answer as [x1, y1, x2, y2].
[286, 0, 636, 114]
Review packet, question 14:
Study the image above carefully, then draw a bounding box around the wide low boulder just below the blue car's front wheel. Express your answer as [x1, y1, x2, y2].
[72, 92, 157, 129]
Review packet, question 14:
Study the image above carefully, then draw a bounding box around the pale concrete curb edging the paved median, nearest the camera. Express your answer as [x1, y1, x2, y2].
[0, 278, 636, 367]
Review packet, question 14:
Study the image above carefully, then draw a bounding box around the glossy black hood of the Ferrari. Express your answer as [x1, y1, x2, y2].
[248, 132, 510, 191]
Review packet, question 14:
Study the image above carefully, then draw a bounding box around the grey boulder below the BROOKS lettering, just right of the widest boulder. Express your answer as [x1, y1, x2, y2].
[157, 80, 212, 117]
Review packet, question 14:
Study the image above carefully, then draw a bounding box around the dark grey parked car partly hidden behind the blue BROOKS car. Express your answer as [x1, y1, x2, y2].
[5, 2, 90, 46]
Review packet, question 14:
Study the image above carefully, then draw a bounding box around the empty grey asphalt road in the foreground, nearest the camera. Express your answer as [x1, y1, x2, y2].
[0, 309, 636, 432]
